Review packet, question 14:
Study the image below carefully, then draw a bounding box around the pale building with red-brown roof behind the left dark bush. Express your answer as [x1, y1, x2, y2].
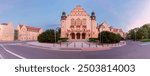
[17, 25, 43, 41]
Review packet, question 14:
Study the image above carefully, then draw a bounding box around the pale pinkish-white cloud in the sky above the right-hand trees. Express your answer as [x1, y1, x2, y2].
[127, 0, 150, 30]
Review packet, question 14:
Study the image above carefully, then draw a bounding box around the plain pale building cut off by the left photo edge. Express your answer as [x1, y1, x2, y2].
[0, 22, 14, 41]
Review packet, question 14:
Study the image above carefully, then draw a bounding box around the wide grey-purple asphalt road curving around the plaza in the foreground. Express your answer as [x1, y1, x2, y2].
[0, 41, 150, 59]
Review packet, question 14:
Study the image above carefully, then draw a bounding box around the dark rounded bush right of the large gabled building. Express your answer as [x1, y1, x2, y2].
[98, 31, 121, 43]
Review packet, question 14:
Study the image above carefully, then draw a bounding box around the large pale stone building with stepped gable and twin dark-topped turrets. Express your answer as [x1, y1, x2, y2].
[61, 5, 98, 40]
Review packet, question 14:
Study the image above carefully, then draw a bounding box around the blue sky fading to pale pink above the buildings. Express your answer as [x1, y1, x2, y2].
[0, 0, 150, 32]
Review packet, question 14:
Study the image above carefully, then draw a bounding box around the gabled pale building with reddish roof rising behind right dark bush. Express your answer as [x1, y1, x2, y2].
[97, 22, 127, 39]
